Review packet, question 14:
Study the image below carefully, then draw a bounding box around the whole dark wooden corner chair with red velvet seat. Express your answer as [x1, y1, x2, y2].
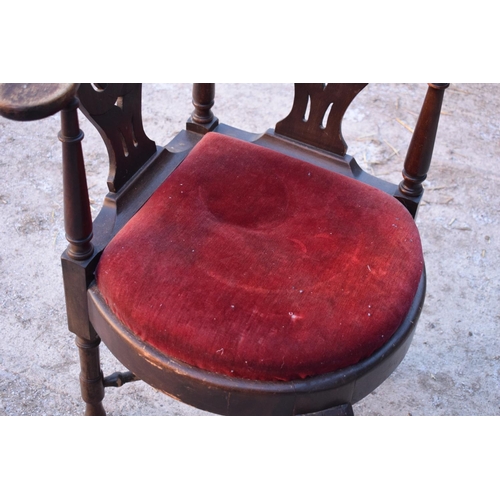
[0, 83, 448, 415]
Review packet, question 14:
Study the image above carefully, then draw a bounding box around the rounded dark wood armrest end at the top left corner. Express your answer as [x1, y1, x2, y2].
[0, 83, 79, 121]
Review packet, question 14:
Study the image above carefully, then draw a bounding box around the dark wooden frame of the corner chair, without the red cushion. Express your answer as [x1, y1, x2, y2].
[0, 84, 448, 415]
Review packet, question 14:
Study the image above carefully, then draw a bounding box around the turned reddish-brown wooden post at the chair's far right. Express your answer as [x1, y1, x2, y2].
[399, 83, 450, 198]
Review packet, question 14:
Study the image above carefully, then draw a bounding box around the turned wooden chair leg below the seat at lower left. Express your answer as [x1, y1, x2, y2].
[75, 337, 106, 416]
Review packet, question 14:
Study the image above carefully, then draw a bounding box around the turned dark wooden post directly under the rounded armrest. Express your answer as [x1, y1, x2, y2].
[58, 97, 94, 260]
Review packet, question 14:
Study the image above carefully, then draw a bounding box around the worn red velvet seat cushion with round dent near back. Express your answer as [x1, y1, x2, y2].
[97, 133, 423, 380]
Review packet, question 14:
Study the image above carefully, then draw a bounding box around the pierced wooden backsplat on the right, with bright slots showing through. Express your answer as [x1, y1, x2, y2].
[275, 83, 367, 156]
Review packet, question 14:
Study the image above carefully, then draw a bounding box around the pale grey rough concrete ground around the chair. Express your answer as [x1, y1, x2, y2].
[0, 84, 500, 415]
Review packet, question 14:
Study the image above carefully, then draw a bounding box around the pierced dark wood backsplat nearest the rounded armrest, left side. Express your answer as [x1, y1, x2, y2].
[78, 83, 156, 192]
